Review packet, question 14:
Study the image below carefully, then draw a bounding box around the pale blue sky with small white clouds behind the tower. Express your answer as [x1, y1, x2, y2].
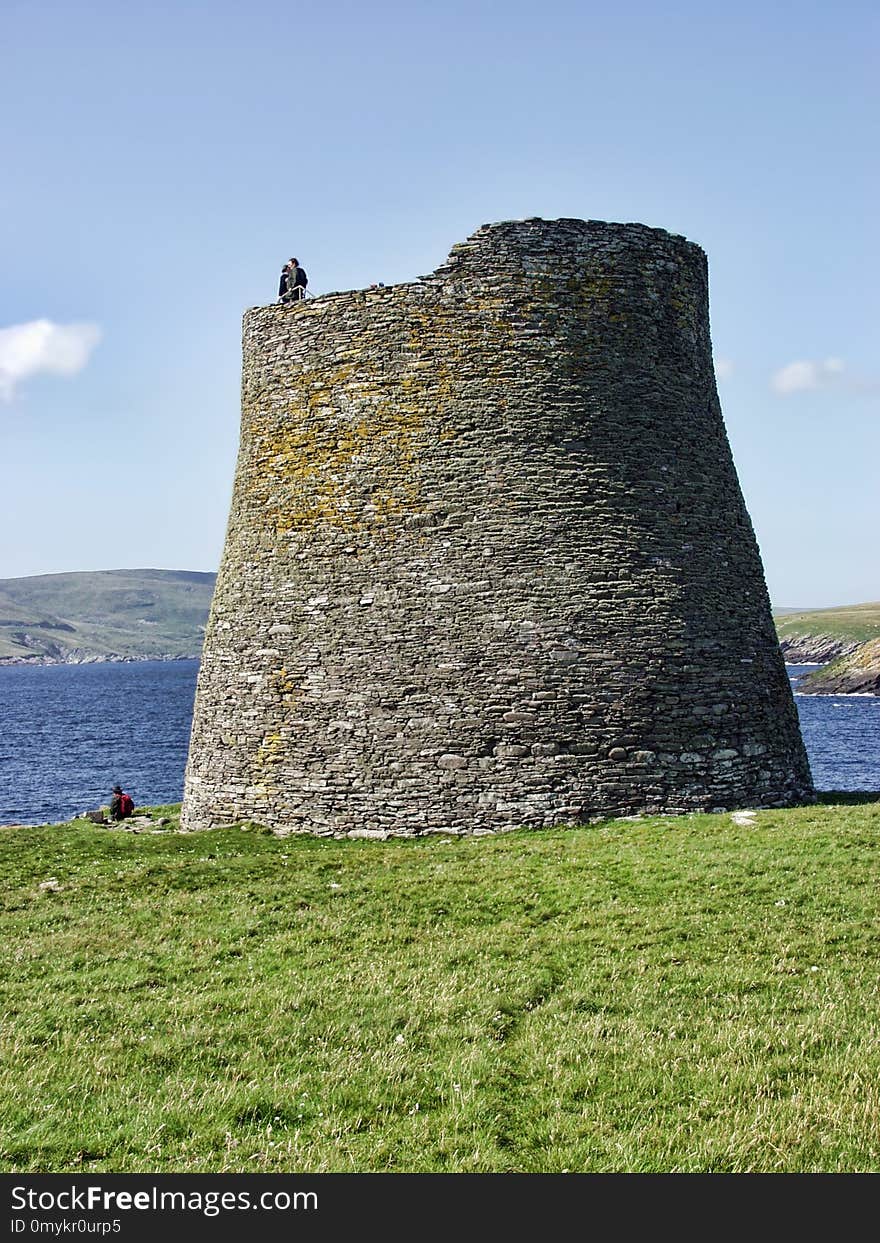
[0, 0, 880, 607]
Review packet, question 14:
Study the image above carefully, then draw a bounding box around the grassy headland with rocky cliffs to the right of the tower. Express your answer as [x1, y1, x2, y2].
[773, 602, 880, 695]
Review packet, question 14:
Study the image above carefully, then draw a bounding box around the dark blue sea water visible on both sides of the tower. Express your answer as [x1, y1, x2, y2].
[0, 660, 880, 824]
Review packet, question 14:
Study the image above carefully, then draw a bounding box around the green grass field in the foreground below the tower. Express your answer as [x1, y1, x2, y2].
[0, 796, 880, 1172]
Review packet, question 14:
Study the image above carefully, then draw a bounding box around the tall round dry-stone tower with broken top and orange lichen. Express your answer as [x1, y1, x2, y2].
[176, 219, 813, 834]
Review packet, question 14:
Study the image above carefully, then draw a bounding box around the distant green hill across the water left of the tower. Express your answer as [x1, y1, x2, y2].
[0, 569, 216, 665]
